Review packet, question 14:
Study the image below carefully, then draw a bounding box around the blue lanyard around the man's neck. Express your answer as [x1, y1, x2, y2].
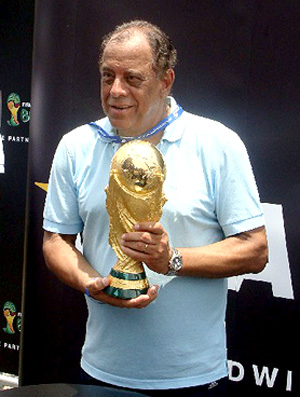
[89, 105, 183, 143]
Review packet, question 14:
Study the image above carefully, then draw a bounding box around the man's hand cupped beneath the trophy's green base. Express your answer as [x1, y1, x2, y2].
[87, 277, 158, 309]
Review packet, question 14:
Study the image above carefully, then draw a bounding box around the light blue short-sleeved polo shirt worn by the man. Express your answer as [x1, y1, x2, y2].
[44, 99, 264, 389]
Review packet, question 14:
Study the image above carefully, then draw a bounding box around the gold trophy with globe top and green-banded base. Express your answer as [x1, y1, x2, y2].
[104, 140, 166, 299]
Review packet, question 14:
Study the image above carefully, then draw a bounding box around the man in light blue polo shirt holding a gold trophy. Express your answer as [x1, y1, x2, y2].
[43, 21, 267, 396]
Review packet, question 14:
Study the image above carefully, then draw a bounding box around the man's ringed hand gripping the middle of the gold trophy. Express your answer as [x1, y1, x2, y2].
[121, 222, 172, 274]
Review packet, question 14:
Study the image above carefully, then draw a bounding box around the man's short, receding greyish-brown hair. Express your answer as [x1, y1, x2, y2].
[99, 20, 177, 77]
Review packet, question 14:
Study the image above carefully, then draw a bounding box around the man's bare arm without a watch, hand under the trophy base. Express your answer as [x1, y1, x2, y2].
[43, 231, 157, 309]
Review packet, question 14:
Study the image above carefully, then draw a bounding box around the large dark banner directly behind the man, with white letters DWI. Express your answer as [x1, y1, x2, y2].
[20, 0, 300, 397]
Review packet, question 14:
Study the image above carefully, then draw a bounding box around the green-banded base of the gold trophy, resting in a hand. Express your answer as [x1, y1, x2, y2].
[103, 269, 149, 299]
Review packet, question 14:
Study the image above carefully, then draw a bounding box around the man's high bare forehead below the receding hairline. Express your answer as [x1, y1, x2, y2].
[102, 33, 153, 68]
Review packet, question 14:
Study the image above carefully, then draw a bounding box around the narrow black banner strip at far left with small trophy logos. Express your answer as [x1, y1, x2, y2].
[0, 0, 34, 374]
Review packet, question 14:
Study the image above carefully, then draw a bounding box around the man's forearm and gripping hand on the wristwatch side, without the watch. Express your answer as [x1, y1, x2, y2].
[122, 222, 268, 278]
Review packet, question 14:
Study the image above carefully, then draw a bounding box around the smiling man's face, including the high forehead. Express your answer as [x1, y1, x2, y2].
[100, 33, 166, 136]
